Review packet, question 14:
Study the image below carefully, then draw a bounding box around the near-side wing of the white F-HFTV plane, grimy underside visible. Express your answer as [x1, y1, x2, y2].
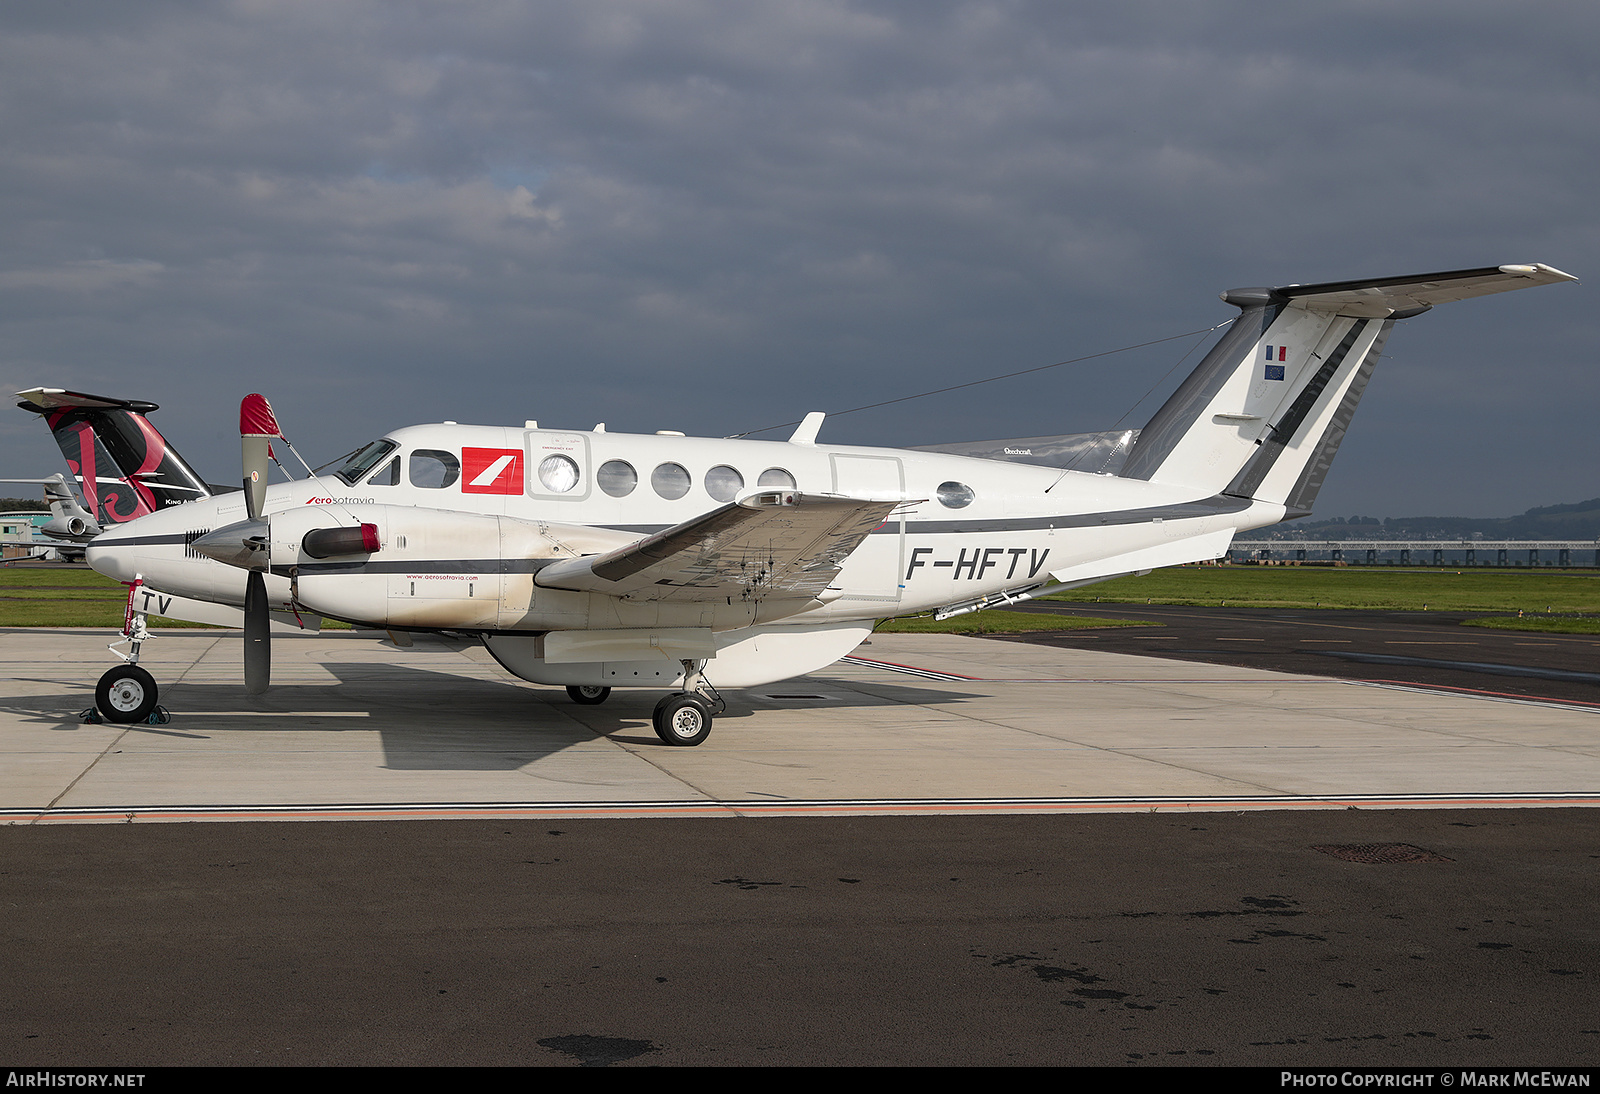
[534, 491, 901, 601]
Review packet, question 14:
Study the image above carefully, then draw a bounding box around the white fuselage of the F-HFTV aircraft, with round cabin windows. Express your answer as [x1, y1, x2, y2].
[90, 424, 1283, 633]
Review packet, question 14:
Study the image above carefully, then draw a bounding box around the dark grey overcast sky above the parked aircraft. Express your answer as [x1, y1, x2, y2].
[0, 0, 1600, 517]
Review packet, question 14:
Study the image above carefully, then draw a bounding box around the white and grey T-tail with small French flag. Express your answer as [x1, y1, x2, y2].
[1120, 266, 1578, 515]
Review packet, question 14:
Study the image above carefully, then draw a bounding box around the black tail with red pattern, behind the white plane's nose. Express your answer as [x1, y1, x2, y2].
[18, 387, 211, 526]
